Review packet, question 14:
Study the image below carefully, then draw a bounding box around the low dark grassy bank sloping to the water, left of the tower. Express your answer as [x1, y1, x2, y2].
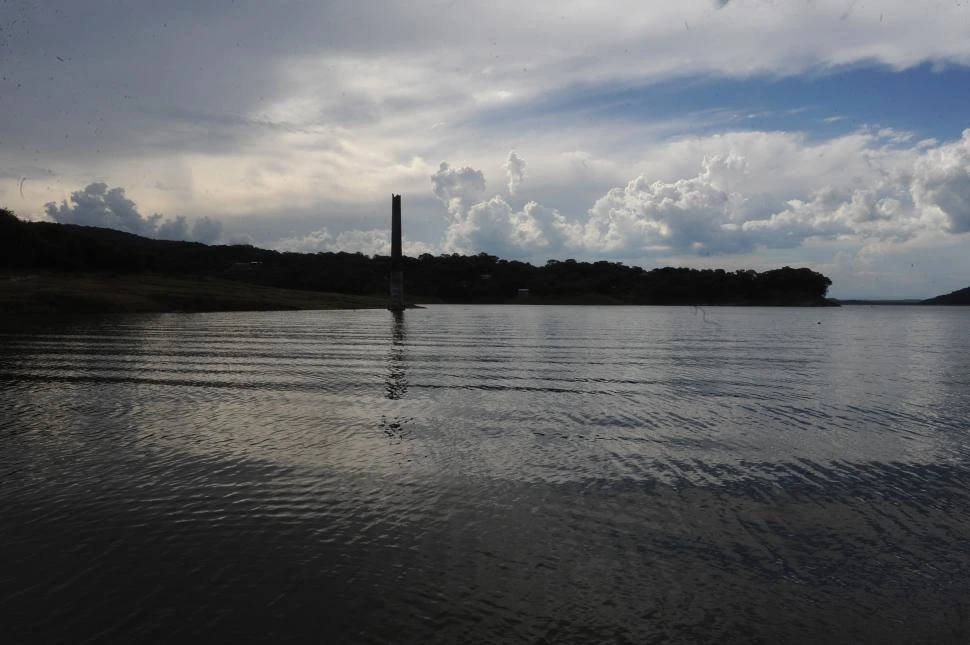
[0, 272, 387, 314]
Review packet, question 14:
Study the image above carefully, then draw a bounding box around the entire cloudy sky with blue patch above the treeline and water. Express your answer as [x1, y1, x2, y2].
[0, 0, 970, 298]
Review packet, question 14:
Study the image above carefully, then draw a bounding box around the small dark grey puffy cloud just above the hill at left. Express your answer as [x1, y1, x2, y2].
[44, 182, 222, 244]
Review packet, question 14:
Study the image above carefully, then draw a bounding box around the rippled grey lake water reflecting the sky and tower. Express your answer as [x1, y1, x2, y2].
[0, 306, 970, 643]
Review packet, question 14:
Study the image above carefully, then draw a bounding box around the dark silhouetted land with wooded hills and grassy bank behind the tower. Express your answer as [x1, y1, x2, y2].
[0, 209, 834, 311]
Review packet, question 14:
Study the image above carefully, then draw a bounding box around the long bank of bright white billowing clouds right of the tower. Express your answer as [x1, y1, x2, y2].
[432, 128, 970, 257]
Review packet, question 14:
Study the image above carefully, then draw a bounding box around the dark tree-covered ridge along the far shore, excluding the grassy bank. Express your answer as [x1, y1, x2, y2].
[0, 209, 831, 306]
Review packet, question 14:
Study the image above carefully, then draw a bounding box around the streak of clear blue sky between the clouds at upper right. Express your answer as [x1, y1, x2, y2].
[473, 64, 970, 141]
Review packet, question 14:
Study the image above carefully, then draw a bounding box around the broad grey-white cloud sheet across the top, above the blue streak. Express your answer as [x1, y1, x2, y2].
[9, 0, 970, 212]
